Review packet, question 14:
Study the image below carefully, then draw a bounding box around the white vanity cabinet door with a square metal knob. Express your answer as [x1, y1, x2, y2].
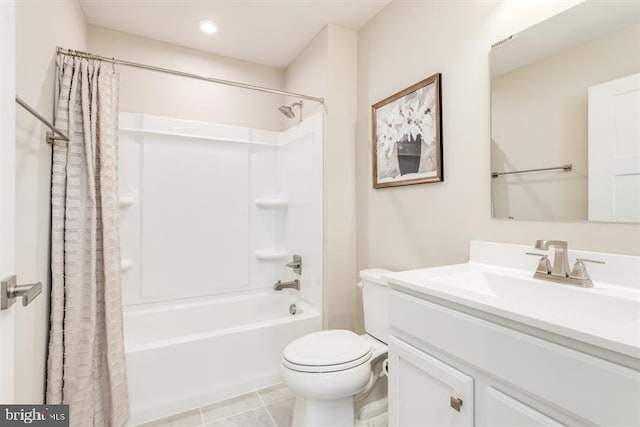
[389, 337, 473, 427]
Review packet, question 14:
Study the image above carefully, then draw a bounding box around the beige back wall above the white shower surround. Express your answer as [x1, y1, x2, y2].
[88, 25, 284, 130]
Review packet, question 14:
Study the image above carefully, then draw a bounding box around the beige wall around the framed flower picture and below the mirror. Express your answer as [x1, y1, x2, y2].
[357, 0, 640, 280]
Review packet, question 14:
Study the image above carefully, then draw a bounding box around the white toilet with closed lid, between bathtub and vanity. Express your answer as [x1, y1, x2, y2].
[281, 269, 390, 427]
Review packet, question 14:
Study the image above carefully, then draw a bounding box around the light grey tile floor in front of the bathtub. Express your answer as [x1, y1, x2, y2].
[138, 384, 295, 427]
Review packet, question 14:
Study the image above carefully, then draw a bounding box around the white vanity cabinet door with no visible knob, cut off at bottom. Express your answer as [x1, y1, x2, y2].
[486, 387, 564, 427]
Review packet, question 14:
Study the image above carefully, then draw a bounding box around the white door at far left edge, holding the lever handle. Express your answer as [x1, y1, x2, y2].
[0, 0, 16, 403]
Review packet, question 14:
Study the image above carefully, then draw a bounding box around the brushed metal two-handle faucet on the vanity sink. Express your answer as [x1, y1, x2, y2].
[527, 240, 604, 288]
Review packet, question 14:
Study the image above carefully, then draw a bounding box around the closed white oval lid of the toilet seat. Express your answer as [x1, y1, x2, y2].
[282, 330, 371, 367]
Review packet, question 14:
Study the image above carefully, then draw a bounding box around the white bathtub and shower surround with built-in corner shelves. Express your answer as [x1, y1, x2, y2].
[120, 113, 323, 423]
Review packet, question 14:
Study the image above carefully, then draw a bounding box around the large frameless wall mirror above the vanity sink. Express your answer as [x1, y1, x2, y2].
[490, 1, 640, 222]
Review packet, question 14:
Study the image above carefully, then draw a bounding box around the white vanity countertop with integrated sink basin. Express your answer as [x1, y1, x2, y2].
[386, 262, 640, 358]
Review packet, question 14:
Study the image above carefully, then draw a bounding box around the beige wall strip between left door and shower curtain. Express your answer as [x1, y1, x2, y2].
[15, 1, 86, 403]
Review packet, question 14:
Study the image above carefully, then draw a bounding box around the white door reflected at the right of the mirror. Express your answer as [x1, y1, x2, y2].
[589, 74, 640, 222]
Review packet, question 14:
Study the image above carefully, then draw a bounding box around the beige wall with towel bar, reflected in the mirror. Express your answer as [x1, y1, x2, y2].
[491, 20, 640, 220]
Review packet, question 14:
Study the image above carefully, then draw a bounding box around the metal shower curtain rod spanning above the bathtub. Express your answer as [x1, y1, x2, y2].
[57, 47, 324, 104]
